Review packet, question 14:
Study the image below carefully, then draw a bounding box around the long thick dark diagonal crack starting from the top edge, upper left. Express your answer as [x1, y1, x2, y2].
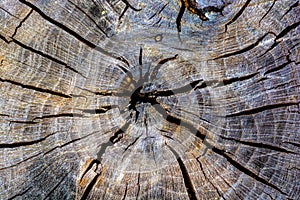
[19, 0, 116, 59]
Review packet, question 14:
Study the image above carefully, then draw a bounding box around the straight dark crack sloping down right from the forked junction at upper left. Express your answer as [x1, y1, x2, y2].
[12, 38, 87, 78]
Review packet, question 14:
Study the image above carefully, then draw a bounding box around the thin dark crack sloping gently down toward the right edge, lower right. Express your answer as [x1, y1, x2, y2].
[220, 136, 296, 154]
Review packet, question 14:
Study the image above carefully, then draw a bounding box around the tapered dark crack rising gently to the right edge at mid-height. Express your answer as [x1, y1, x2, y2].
[225, 102, 299, 117]
